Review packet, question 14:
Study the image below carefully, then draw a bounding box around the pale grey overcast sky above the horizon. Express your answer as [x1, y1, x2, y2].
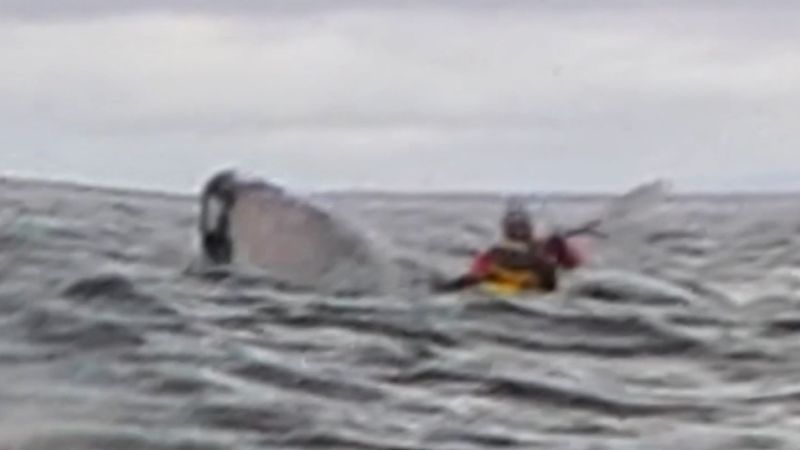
[0, 0, 800, 191]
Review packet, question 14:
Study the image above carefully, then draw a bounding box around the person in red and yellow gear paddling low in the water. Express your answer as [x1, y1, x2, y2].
[439, 199, 582, 291]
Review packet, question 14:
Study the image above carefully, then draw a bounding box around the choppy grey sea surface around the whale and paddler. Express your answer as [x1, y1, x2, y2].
[0, 180, 800, 450]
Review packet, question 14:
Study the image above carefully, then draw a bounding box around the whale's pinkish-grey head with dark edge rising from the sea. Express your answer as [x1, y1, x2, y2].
[199, 169, 385, 291]
